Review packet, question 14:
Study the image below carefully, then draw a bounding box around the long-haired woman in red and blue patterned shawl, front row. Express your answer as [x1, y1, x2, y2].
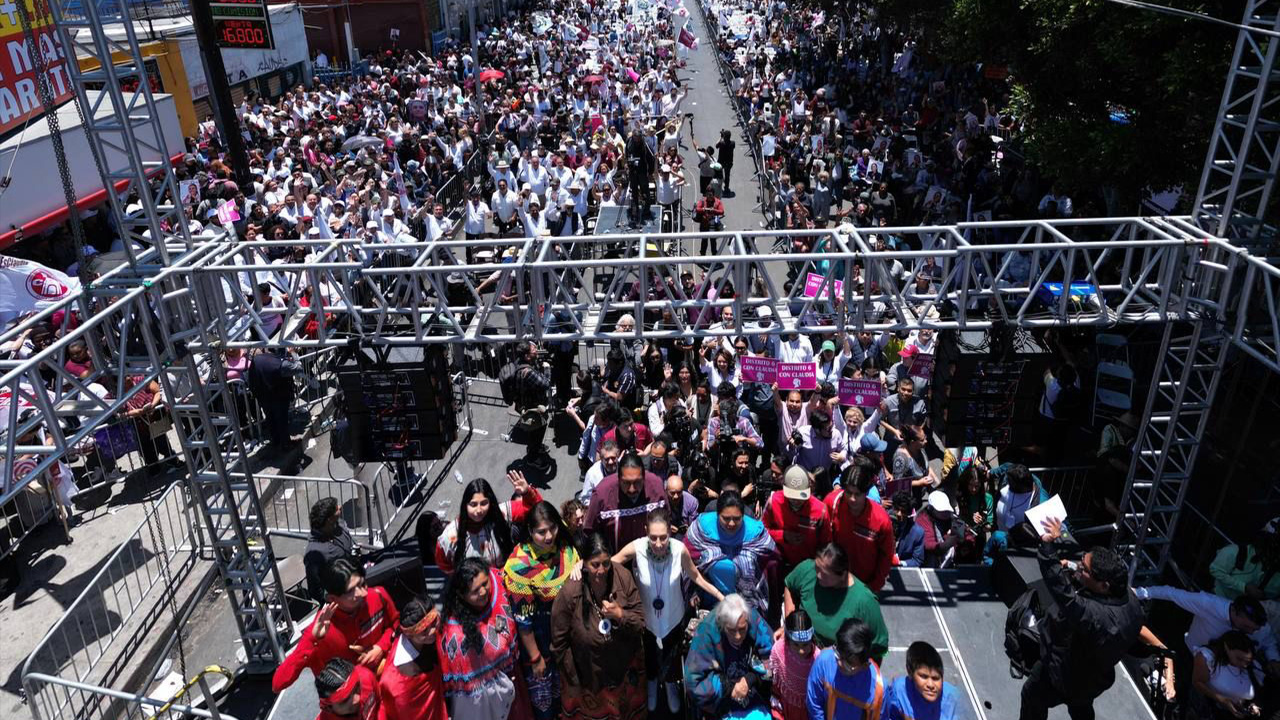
[436, 557, 531, 720]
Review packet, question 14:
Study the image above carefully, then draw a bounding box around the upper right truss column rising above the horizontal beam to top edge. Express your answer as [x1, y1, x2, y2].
[1193, 0, 1280, 255]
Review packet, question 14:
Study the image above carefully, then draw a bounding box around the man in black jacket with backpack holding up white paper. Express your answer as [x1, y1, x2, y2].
[1019, 520, 1144, 720]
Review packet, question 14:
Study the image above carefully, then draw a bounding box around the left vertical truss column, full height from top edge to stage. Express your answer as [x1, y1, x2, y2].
[49, 0, 292, 665]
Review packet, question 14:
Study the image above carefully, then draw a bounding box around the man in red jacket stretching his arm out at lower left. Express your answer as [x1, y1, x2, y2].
[271, 557, 399, 693]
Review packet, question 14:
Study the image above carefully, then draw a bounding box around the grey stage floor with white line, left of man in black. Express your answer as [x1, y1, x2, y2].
[881, 568, 1155, 720]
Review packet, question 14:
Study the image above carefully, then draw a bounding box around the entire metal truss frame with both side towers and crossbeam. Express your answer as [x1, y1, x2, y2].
[0, 0, 1280, 712]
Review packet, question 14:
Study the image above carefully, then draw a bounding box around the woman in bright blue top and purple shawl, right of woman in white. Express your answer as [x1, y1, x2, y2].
[685, 491, 778, 614]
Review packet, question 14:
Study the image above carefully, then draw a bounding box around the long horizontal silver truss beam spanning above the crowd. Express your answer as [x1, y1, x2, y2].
[192, 218, 1189, 347]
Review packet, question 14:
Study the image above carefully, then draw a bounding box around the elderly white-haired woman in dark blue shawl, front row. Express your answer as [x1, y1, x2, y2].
[685, 593, 773, 720]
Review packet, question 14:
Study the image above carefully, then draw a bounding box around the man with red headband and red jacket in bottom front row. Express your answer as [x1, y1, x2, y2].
[378, 598, 449, 720]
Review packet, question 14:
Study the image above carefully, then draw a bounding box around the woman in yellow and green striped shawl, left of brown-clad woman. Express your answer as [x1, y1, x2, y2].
[503, 501, 579, 720]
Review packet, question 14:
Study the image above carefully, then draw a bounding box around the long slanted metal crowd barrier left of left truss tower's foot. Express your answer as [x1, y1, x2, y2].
[22, 483, 204, 720]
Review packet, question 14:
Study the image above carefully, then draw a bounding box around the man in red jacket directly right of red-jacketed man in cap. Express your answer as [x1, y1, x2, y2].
[827, 455, 895, 592]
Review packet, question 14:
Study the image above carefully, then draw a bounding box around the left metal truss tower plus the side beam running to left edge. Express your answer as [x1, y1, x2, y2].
[8, 0, 293, 703]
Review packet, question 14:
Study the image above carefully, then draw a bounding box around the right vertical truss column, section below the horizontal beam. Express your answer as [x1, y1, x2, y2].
[1114, 245, 1240, 580]
